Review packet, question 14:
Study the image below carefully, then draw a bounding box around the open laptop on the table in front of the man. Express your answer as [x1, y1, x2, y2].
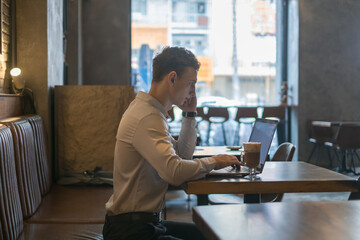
[207, 118, 279, 177]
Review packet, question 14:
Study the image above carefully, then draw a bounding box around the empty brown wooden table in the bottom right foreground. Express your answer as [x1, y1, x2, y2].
[193, 201, 360, 240]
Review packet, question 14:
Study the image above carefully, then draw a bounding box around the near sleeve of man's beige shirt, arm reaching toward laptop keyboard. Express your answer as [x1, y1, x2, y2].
[132, 114, 215, 186]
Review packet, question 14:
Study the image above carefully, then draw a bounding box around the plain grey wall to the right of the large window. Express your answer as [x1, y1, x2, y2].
[296, 0, 360, 166]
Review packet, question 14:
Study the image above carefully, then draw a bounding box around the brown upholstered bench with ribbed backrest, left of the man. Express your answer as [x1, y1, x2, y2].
[0, 115, 112, 240]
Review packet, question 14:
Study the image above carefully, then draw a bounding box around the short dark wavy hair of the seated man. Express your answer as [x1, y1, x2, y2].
[153, 47, 200, 82]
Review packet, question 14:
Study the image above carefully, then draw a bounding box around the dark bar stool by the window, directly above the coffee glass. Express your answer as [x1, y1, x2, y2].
[234, 107, 257, 145]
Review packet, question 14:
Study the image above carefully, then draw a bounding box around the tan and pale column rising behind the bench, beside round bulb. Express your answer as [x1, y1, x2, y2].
[14, 0, 64, 171]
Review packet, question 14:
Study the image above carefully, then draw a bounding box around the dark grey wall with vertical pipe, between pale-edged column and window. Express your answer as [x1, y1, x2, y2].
[65, 0, 131, 85]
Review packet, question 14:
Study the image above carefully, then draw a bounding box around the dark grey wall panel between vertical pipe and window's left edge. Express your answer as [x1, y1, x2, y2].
[82, 0, 131, 85]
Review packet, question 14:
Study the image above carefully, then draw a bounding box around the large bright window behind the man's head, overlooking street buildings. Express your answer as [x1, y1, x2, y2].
[131, 0, 280, 105]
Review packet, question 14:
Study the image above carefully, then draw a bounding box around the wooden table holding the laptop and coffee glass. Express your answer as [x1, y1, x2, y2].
[183, 162, 359, 205]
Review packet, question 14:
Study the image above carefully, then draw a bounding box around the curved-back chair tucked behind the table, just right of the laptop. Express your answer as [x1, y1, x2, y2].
[209, 142, 296, 205]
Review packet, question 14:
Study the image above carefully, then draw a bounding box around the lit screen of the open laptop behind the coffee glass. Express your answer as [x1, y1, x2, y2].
[249, 118, 279, 166]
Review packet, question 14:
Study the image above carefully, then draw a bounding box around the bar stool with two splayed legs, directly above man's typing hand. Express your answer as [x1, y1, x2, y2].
[206, 107, 229, 145]
